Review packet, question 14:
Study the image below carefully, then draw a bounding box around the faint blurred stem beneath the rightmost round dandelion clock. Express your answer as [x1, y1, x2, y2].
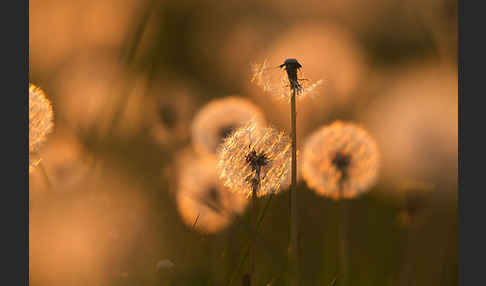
[339, 184, 349, 286]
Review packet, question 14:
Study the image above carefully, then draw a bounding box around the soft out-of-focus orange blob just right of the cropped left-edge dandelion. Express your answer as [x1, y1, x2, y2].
[54, 53, 125, 136]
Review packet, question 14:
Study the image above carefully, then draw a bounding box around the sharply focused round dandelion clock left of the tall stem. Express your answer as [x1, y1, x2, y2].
[218, 122, 291, 196]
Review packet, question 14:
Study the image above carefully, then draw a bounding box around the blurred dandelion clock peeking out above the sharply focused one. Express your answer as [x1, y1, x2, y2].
[192, 96, 266, 155]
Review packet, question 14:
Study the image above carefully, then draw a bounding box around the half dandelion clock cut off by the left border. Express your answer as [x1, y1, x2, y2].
[29, 83, 54, 173]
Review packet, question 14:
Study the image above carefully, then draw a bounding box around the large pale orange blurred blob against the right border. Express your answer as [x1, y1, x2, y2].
[358, 63, 458, 191]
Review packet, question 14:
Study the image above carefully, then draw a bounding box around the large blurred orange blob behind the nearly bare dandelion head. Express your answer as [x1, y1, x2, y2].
[252, 21, 366, 105]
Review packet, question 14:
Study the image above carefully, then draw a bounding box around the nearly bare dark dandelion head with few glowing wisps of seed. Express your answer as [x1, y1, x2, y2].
[251, 59, 323, 100]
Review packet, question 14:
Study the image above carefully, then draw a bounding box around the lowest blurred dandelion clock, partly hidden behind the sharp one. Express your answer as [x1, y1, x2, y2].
[176, 157, 248, 233]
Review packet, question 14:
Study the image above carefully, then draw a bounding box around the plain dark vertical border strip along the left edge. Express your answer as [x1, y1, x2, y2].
[0, 0, 29, 285]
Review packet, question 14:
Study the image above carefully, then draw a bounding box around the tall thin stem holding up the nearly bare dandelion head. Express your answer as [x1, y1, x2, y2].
[290, 88, 299, 286]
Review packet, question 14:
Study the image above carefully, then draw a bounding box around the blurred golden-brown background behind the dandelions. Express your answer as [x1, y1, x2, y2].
[29, 0, 458, 286]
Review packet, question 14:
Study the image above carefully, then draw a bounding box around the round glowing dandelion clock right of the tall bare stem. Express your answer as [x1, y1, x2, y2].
[302, 121, 379, 199]
